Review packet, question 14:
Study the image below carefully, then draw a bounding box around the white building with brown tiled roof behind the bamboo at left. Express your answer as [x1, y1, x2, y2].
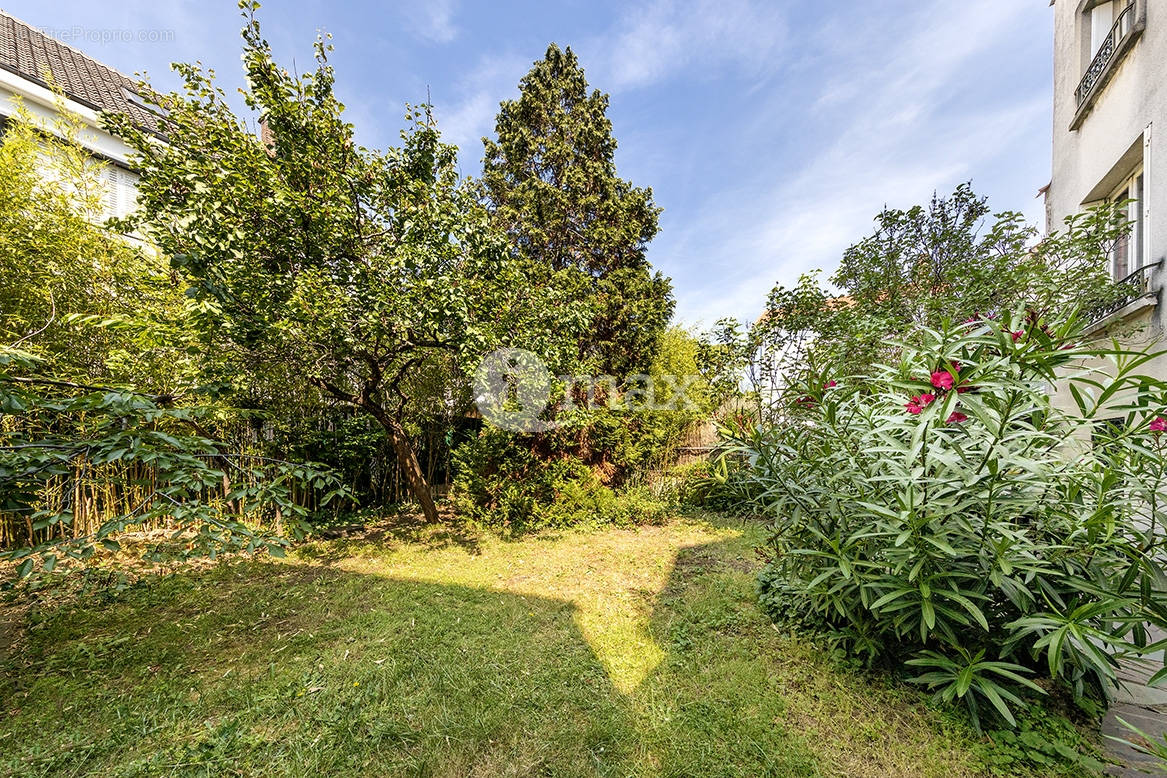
[0, 12, 158, 225]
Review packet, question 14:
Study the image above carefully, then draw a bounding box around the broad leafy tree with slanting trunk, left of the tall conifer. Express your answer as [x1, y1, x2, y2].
[102, 0, 534, 520]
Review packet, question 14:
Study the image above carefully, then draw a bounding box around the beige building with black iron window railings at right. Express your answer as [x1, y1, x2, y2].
[1046, 0, 1167, 352]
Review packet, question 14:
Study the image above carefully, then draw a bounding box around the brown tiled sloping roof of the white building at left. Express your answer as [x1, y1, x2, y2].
[0, 10, 158, 129]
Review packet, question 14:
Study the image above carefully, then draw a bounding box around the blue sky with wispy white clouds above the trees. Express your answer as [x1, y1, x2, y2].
[0, 0, 1053, 328]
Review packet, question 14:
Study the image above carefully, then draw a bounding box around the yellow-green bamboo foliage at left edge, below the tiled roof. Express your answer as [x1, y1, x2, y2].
[0, 105, 190, 394]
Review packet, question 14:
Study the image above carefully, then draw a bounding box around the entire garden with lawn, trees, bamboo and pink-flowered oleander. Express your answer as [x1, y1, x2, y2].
[0, 1, 1167, 776]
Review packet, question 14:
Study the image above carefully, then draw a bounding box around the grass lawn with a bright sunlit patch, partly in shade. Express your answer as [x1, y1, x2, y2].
[0, 519, 1082, 778]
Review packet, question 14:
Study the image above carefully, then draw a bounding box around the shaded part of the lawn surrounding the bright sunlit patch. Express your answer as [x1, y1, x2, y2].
[0, 530, 818, 776]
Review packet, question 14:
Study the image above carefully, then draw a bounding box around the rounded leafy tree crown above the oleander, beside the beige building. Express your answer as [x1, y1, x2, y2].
[831, 184, 1126, 338]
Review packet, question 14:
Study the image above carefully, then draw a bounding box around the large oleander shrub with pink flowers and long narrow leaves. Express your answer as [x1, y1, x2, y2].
[729, 315, 1167, 726]
